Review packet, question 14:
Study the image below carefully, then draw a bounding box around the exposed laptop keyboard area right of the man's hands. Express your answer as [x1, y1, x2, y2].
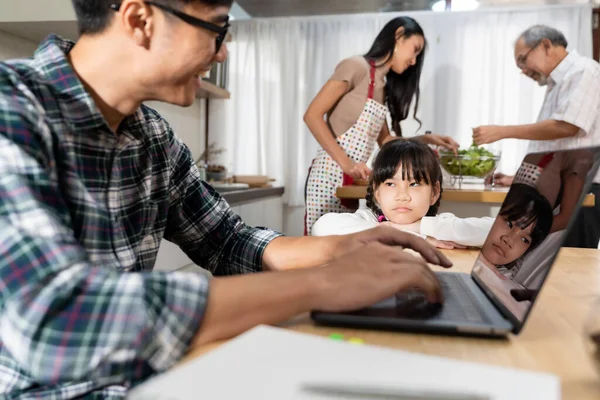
[436, 274, 491, 323]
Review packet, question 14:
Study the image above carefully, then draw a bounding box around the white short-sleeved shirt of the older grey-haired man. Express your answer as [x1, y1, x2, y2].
[528, 51, 600, 182]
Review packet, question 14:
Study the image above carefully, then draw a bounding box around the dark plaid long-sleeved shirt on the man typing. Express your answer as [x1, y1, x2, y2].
[0, 36, 278, 399]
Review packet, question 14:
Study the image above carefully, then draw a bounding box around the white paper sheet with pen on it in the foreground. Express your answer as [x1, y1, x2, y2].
[129, 326, 560, 400]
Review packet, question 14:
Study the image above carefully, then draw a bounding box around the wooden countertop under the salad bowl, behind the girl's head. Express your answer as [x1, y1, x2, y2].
[335, 184, 595, 207]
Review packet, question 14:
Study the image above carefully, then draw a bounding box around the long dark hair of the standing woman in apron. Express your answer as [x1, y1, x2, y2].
[364, 17, 427, 136]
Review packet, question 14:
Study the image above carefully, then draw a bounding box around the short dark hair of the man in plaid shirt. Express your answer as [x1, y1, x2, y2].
[72, 0, 233, 35]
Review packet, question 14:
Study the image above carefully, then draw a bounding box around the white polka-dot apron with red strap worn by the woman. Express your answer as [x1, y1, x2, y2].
[304, 63, 388, 235]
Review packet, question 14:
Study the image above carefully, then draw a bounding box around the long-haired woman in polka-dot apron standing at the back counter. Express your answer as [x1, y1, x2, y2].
[304, 17, 458, 235]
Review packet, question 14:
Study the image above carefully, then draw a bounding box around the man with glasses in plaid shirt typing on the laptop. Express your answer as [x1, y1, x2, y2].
[0, 0, 450, 399]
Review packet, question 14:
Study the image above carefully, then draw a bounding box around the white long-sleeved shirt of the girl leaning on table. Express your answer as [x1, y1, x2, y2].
[311, 208, 494, 247]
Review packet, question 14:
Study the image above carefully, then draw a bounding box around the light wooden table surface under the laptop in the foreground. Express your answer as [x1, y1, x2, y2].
[186, 249, 600, 400]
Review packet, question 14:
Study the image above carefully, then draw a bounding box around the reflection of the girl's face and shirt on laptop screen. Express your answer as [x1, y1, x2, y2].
[473, 183, 552, 318]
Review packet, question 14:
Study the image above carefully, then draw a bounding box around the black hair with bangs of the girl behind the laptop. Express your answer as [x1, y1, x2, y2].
[366, 139, 443, 218]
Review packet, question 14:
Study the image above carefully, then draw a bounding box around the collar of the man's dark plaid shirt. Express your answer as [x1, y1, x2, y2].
[33, 35, 144, 139]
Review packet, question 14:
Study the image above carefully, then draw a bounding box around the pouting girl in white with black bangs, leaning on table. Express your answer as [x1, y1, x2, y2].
[312, 139, 494, 248]
